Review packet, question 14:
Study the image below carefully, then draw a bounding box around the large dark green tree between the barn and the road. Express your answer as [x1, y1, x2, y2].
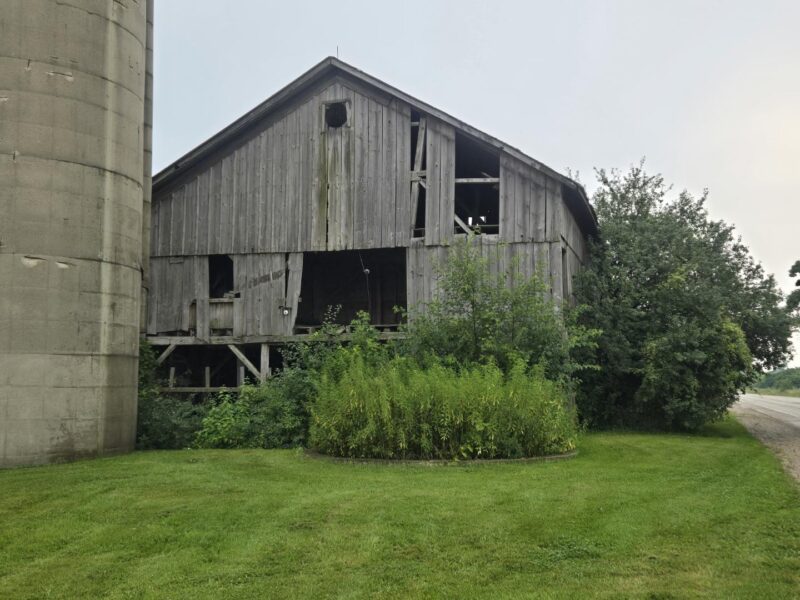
[577, 165, 792, 429]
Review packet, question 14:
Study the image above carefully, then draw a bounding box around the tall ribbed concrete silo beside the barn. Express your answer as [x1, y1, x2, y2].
[0, 0, 149, 466]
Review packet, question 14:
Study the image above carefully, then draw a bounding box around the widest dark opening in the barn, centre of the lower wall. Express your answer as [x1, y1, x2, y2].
[295, 248, 406, 333]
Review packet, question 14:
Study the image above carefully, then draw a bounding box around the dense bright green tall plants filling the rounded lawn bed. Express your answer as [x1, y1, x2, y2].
[309, 347, 576, 459]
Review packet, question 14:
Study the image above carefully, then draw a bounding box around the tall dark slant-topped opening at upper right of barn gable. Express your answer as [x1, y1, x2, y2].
[454, 131, 500, 234]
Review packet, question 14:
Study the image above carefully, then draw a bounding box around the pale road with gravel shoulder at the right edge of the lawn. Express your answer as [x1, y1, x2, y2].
[732, 394, 800, 480]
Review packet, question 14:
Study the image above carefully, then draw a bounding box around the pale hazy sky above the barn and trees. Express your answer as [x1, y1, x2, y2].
[153, 0, 800, 366]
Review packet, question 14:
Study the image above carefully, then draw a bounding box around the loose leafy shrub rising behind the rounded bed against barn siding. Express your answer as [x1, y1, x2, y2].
[399, 239, 596, 382]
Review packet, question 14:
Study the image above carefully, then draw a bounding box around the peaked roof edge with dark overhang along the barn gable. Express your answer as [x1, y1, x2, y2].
[153, 56, 597, 235]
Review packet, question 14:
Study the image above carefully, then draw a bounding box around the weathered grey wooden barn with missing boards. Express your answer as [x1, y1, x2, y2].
[147, 58, 596, 391]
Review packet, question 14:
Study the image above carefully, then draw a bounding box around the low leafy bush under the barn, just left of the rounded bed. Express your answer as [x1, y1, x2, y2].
[195, 368, 315, 448]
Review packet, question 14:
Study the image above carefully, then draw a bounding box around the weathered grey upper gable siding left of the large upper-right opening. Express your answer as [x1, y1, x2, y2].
[151, 81, 412, 256]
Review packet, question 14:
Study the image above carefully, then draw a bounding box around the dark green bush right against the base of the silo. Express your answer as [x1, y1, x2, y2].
[136, 342, 207, 449]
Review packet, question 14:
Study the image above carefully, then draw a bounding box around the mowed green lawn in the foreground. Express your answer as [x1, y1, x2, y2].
[0, 420, 800, 599]
